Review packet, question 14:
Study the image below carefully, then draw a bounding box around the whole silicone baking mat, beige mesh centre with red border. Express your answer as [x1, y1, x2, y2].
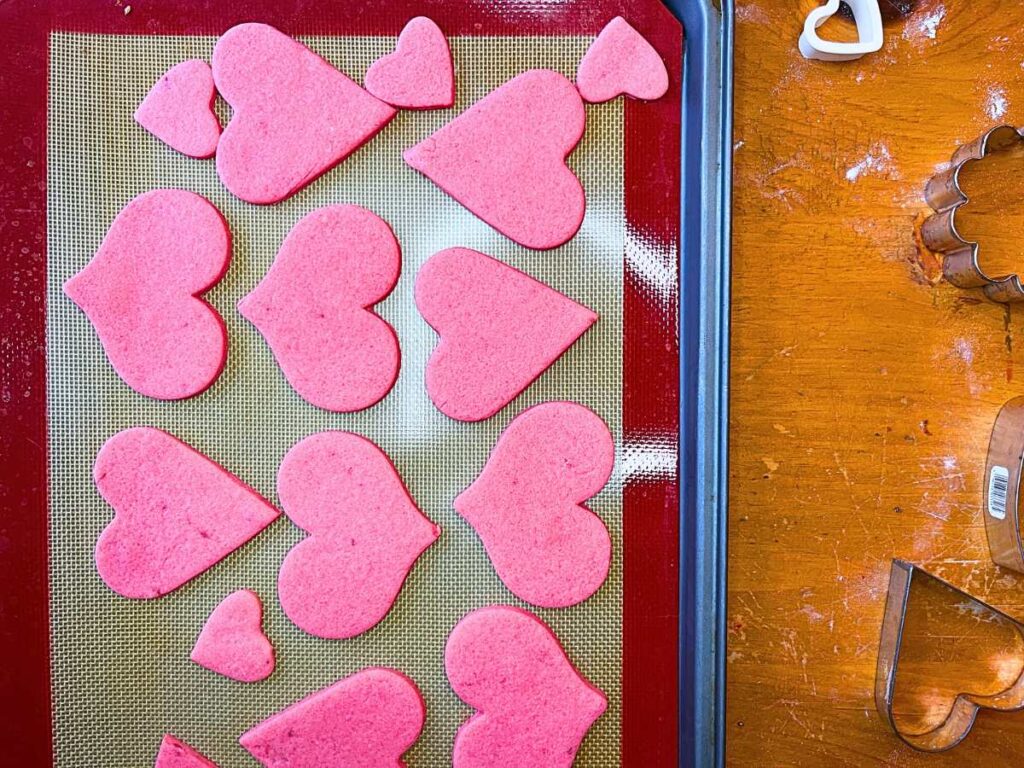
[0, 0, 682, 768]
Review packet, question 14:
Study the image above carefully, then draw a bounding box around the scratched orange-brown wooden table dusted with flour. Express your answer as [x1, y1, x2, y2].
[726, 0, 1024, 767]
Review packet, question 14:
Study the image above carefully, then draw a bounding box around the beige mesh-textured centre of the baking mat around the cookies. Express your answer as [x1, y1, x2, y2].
[47, 33, 626, 768]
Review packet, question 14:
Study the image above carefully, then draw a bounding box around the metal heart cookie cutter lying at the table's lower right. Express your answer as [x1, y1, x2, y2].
[874, 560, 1024, 752]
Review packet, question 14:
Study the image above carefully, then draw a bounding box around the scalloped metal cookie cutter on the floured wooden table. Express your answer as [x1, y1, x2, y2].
[921, 125, 1024, 303]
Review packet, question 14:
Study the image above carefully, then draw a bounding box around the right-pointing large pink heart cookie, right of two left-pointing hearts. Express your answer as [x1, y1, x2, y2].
[416, 248, 597, 421]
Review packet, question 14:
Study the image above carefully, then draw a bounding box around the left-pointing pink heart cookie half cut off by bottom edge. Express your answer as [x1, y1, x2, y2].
[239, 668, 426, 768]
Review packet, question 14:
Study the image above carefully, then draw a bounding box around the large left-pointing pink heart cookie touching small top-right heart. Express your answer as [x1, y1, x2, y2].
[402, 70, 586, 249]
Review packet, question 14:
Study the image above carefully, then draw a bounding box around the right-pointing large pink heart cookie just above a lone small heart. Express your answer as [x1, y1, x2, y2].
[93, 427, 280, 598]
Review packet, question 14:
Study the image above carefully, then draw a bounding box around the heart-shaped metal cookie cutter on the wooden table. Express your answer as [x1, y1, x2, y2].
[874, 560, 1024, 752]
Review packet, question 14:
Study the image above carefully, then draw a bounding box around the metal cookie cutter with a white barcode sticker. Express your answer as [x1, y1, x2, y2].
[982, 396, 1024, 573]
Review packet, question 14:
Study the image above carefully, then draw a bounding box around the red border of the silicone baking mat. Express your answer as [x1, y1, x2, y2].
[0, 0, 683, 768]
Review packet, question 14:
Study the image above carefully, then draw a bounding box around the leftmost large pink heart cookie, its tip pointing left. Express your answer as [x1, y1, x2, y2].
[65, 189, 230, 400]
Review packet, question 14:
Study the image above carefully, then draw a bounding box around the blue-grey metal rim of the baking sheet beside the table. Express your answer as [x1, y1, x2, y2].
[665, 0, 733, 766]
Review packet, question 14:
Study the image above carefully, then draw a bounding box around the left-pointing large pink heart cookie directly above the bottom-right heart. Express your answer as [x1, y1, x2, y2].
[455, 402, 615, 608]
